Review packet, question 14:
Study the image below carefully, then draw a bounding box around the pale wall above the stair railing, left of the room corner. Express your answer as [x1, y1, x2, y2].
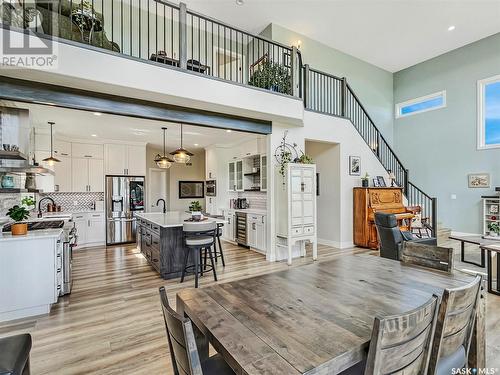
[263, 24, 394, 144]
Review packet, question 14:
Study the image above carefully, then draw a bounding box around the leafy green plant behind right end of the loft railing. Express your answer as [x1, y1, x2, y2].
[248, 60, 292, 95]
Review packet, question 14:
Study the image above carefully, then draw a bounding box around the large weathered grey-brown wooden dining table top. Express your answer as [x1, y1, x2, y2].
[177, 254, 473, 375]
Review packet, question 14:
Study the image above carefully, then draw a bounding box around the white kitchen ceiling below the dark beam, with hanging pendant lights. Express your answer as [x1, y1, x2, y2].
[3, 102, 259, 151]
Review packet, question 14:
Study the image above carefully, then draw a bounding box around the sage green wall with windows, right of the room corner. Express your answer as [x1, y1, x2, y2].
[394, 34, 500, 233]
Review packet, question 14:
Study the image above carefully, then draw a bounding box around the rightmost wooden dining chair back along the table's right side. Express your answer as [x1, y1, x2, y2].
[429, 275, 482, 375]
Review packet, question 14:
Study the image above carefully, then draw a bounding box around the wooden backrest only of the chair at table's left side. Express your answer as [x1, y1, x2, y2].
[160, 287, 203, 375]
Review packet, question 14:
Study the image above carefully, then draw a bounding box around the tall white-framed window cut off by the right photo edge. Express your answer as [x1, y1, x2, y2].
[477, 76, 500, 148]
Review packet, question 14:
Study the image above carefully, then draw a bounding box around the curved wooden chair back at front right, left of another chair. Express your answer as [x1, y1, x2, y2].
[365, 295, 439, 375]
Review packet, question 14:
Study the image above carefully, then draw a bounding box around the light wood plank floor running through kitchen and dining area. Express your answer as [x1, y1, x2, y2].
[0, 243, 500, 375]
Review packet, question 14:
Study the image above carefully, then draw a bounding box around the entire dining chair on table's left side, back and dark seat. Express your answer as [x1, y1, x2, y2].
[159, 287, 234, 375]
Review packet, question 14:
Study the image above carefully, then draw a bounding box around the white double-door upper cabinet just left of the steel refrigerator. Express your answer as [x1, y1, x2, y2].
[71, 158, 104, 192]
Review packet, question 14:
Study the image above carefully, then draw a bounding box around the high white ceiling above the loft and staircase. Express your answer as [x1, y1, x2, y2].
[185, 0, 500, 72]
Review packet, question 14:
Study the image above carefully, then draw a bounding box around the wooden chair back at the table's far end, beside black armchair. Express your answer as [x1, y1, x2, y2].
[401, 241, 453, 273]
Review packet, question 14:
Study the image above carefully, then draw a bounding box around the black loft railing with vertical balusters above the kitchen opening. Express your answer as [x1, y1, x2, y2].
[0, 0, 299, 95]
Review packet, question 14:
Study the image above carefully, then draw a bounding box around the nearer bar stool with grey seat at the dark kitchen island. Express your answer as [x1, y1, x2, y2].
[181, 221, 217, 288]
